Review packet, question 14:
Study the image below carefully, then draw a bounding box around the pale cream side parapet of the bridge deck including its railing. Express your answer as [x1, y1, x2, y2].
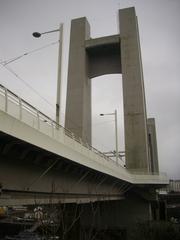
[0, 85, 168, 184]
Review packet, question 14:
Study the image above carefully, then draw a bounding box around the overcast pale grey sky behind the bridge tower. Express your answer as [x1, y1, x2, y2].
[0, 0, 180, 178]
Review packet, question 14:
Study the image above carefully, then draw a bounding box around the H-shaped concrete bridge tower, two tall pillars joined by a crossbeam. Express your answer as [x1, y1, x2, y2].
[65, 8, 150, 172]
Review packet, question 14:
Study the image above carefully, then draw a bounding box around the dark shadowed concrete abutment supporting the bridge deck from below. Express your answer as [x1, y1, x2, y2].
[80, 191, 157, 239]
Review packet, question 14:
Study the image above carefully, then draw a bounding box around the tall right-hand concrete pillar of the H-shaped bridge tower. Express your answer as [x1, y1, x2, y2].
[119, 8, 149, 171]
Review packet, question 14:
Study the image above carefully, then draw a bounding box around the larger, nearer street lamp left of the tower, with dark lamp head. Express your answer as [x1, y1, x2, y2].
[32, 23, 63, 125]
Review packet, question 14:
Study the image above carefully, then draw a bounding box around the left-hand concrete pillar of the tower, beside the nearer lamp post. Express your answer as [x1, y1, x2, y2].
[65, 17, 91, 144]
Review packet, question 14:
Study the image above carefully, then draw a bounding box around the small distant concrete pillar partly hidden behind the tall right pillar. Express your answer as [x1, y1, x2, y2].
[147, 118, 159, 173]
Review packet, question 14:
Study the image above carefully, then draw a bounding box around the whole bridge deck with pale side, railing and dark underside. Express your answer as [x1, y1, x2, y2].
[0, 85, 168, 205]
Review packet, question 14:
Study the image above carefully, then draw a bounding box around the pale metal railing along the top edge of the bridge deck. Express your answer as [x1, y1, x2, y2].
[0, 84, 113, 166]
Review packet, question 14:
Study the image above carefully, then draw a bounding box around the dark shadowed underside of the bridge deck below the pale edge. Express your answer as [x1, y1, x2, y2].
[0, 132, 132, 205]
